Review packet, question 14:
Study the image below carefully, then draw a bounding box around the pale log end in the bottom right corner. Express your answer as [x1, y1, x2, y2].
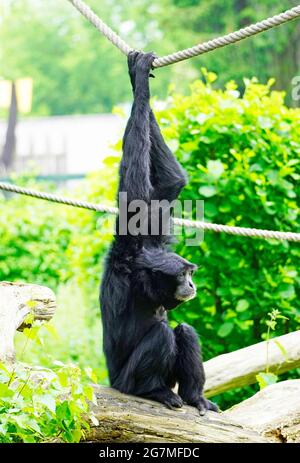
[223, 379, 300, 443]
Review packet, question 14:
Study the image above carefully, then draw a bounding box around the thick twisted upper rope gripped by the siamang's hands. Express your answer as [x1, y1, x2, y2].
[68, 0, 300, 68]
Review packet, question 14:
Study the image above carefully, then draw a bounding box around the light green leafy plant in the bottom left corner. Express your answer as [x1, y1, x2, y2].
[0, 320, 97, 443]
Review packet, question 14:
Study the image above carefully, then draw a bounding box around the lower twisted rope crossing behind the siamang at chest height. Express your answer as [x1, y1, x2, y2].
[0, 182, 300, 242]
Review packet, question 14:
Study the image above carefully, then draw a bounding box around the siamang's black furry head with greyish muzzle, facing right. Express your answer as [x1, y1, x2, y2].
[137, 249, 197, 310]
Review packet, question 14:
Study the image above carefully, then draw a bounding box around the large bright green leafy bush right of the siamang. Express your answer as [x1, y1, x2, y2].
[160, 70, 300, 366]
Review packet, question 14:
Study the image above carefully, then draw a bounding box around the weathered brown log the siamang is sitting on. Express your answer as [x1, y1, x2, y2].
[85, 386, 269, 443]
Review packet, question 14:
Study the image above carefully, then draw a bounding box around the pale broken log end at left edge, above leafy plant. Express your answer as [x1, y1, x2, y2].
[0, 281, 56, 362]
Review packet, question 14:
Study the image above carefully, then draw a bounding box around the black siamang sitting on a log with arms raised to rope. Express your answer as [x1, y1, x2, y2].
[100, 52, 217, 414]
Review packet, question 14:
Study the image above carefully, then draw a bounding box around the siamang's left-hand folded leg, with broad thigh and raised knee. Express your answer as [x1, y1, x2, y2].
[112, 322, 182, 407]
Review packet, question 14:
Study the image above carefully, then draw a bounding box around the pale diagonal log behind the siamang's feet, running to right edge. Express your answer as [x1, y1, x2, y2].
[204, 331, 300, 397]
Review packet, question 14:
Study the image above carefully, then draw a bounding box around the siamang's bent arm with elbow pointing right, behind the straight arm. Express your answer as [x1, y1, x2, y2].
[150, 111, 187, 201]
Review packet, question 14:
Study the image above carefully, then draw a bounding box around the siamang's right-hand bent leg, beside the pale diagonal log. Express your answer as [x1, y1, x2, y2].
[174, 323, 218, 414]
